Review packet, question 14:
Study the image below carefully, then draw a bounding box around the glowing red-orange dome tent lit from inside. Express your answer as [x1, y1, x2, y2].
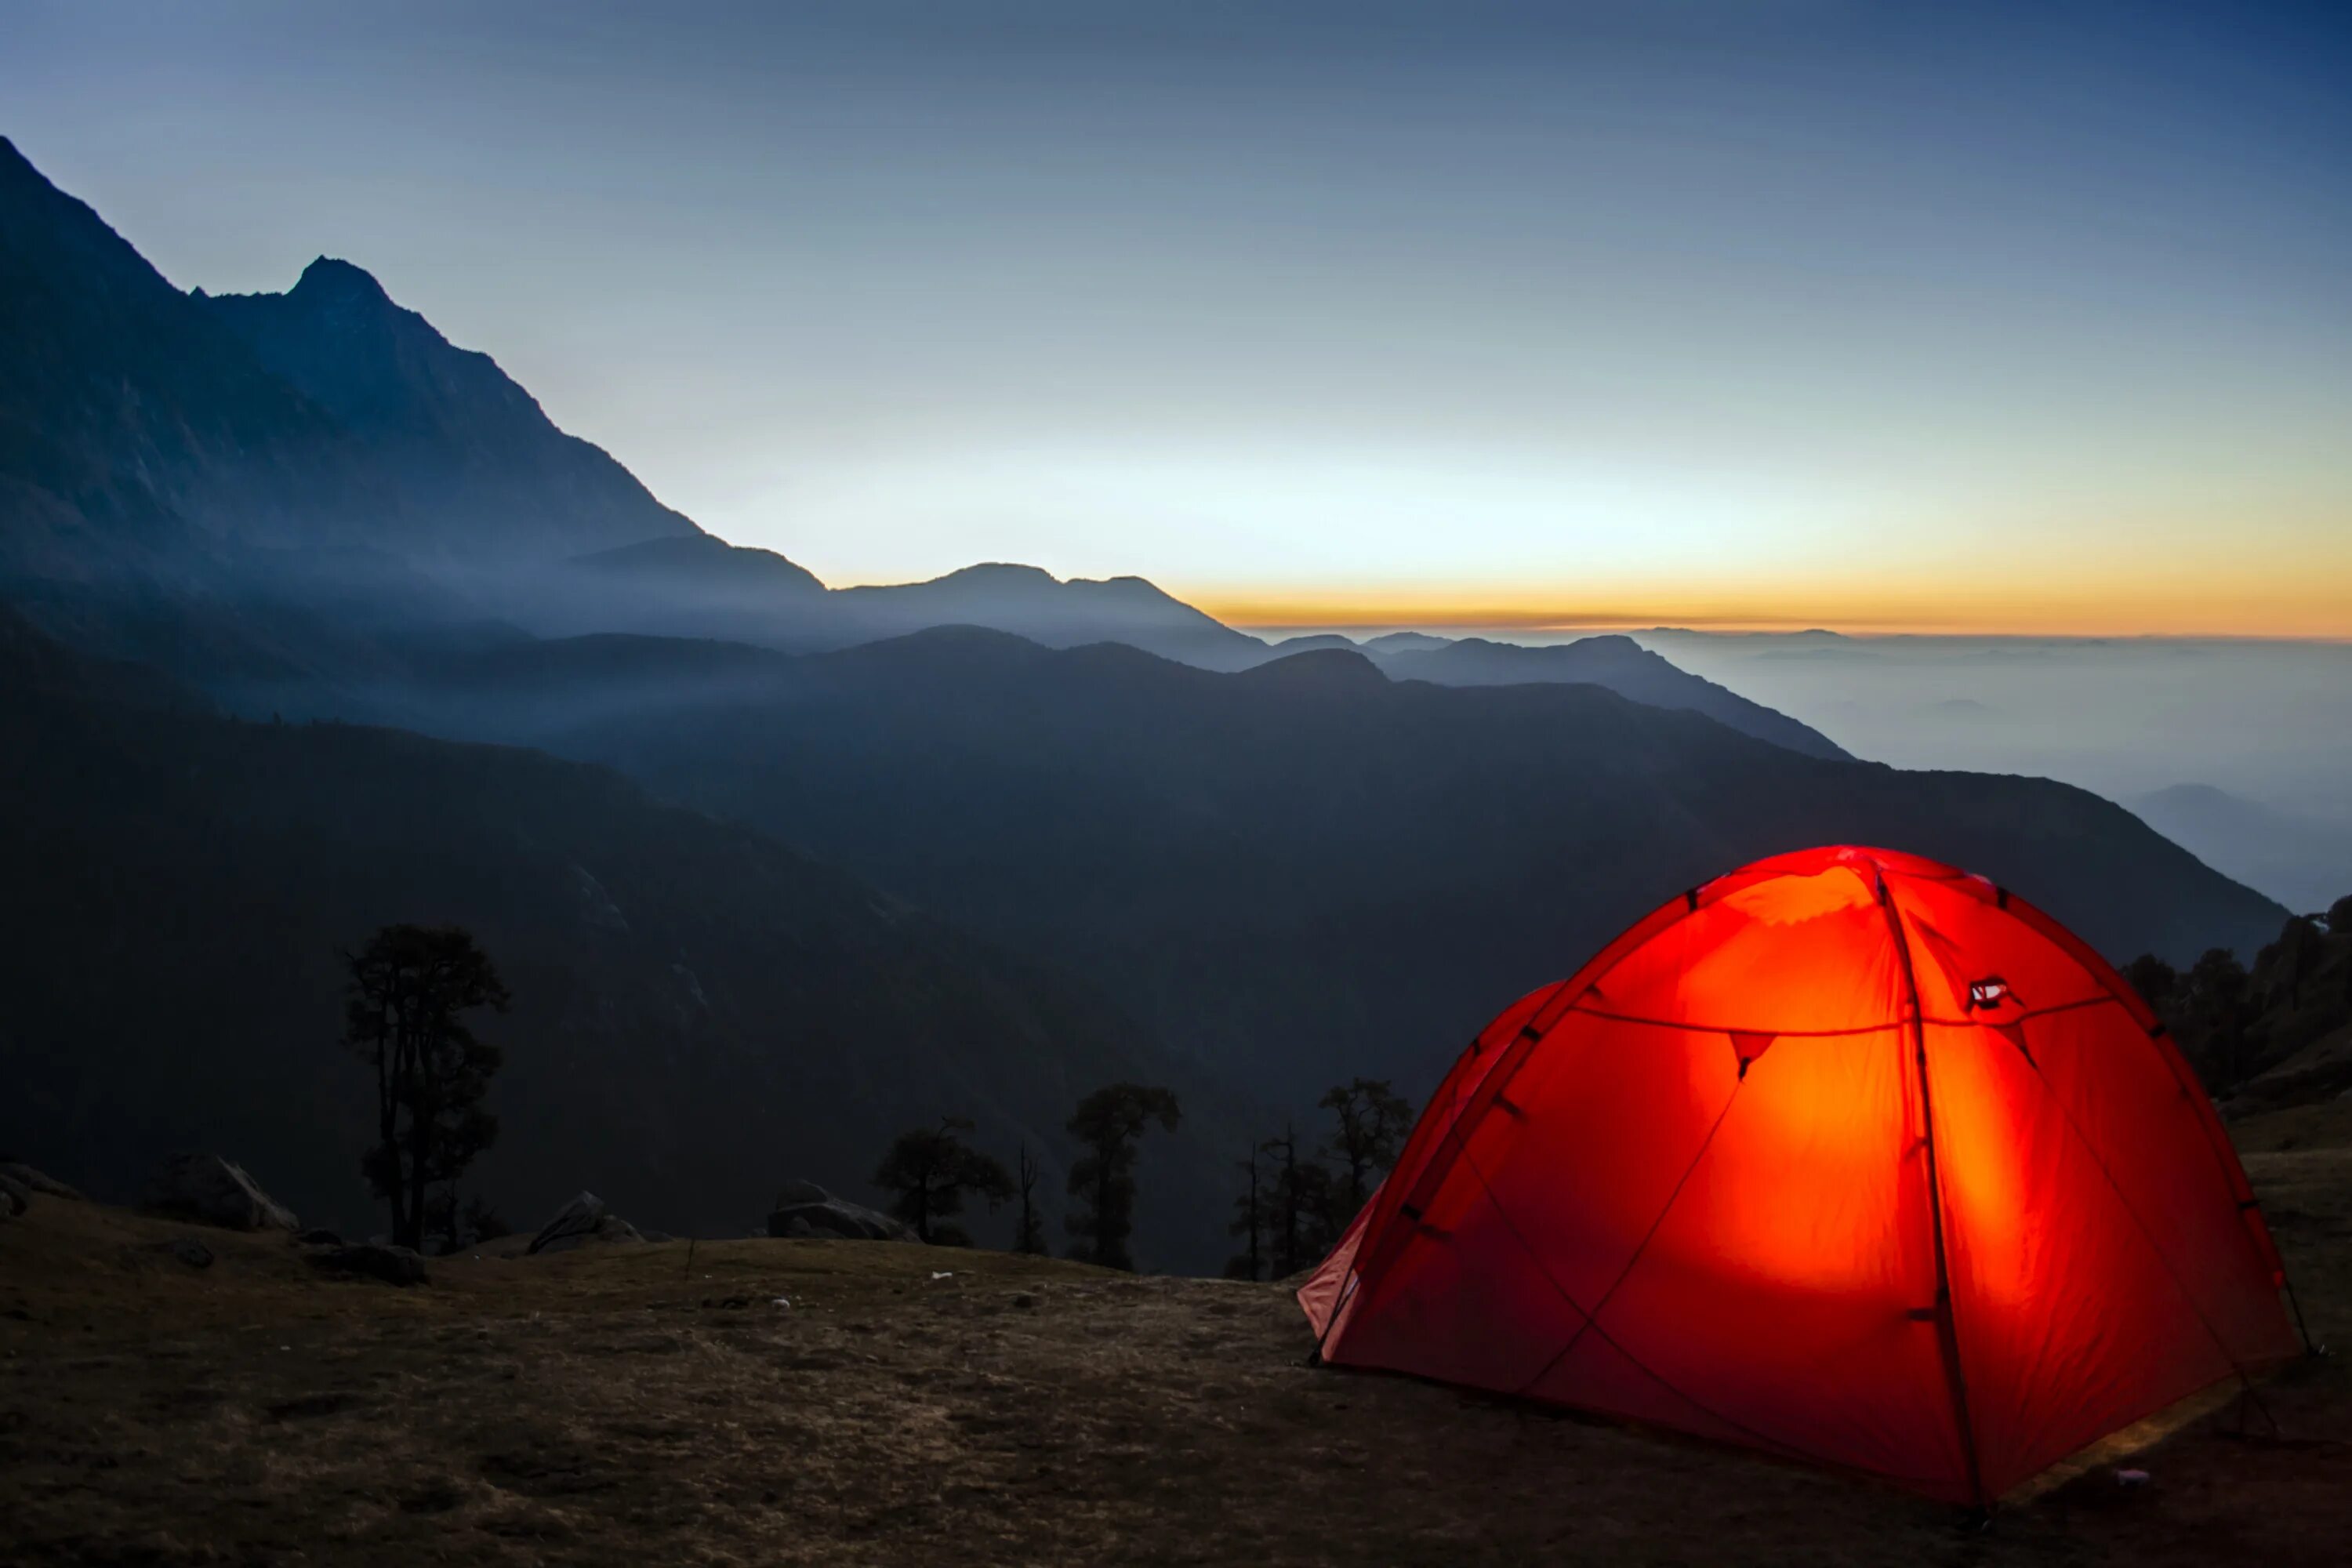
[1298, 848, 2298, 1504]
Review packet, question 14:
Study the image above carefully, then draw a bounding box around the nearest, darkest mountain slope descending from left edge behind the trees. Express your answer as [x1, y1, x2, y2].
[0, 612, 1249, 1269]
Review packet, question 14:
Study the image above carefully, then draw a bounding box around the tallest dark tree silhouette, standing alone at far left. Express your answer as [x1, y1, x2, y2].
[343, 926, 508, 1248]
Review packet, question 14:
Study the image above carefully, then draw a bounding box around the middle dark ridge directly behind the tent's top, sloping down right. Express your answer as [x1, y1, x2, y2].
[395, 630, 2284, 1100]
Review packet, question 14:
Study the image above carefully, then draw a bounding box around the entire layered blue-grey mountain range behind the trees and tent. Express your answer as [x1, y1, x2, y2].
[0, 141, 2284, 1267]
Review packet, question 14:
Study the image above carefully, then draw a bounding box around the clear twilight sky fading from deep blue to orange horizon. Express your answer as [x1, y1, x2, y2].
[0, 0, 2352, 637]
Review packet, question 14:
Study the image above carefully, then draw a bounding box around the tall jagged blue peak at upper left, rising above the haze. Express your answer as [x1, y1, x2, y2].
[0, 139, 694, 576]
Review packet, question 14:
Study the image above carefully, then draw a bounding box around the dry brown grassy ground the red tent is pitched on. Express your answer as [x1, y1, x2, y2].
[0, 1102, 2352, 1568]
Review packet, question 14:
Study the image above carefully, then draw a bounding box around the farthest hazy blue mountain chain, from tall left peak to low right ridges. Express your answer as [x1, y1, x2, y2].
[0, 141, 1872, 755]
